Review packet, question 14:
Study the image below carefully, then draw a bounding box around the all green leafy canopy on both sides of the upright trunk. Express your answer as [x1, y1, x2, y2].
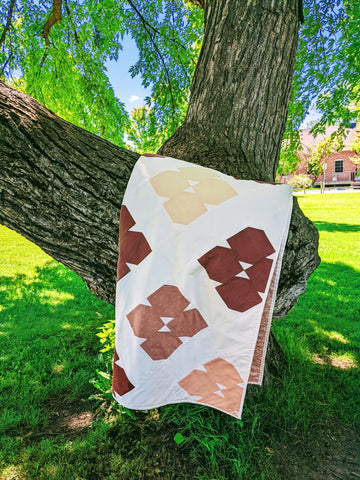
[0, 0, 360, 155]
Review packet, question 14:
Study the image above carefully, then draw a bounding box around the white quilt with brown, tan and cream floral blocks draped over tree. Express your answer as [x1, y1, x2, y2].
[112, 155, 292, 418]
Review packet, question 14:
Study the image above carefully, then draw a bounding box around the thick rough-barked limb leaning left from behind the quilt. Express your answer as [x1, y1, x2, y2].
[0, 82, 139, 303]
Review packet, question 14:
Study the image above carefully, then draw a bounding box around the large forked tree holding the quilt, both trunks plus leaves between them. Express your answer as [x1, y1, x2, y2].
[0, 0, 319, 317]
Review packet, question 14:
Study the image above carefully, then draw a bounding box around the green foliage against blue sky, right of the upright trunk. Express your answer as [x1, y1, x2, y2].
[286, 0, 360, 136]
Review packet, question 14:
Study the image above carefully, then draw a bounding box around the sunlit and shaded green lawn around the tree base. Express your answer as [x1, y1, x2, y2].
[0, 193, 360, 480]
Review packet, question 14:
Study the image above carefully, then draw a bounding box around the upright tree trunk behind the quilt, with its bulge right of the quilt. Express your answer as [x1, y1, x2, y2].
[159, 0, 320, 318]
